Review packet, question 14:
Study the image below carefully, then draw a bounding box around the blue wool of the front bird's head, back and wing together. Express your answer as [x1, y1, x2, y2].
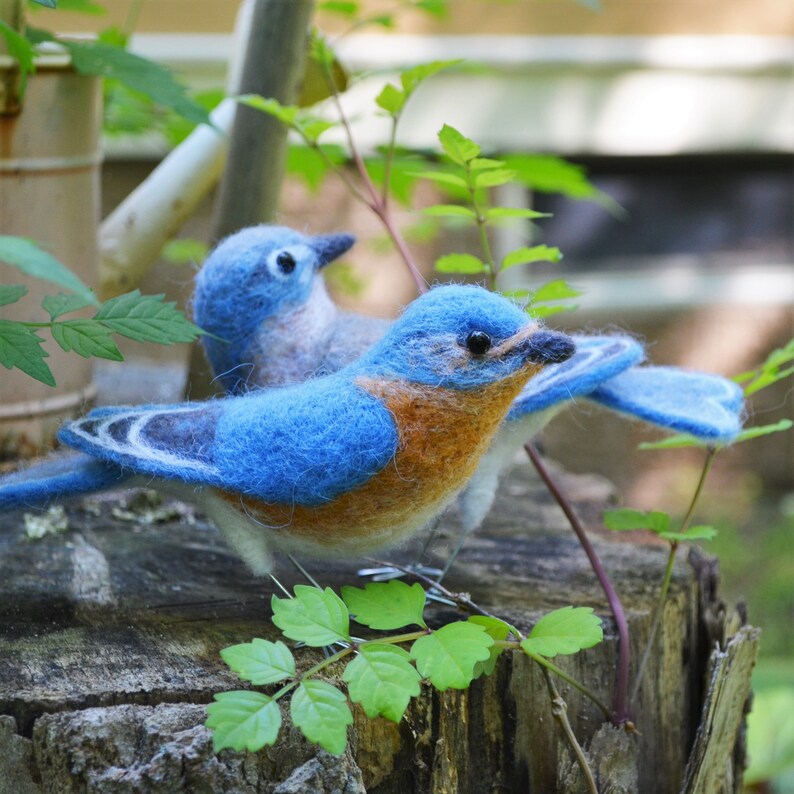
[60, 287, 548, 506]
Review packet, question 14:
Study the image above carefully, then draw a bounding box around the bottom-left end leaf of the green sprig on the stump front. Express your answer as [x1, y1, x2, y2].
[205, 690, 281, 753]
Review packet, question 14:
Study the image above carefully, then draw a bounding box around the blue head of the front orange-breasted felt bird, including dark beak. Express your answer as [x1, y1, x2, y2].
[358, 285, 574, 389]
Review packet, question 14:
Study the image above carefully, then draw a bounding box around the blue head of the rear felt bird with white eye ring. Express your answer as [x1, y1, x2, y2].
[193, 226, 355, 384]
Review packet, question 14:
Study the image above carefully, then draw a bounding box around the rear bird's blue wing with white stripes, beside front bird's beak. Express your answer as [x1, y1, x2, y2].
[507, 336, 645, 420]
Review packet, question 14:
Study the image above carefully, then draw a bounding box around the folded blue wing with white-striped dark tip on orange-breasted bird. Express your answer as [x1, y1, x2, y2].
[60, 376, 398, 505]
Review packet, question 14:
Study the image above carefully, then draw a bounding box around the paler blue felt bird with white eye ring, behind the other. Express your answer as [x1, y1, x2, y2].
[194, 226, 743, 564]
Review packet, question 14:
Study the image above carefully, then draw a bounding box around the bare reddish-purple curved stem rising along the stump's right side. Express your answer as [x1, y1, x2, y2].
[524, 443, 631, 725]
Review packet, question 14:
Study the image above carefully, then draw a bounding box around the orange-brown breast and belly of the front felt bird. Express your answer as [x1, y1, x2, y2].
[215, 367, 539, 555]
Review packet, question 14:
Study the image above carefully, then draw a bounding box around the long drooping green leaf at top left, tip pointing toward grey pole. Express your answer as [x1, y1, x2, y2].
[59, 39, 212, 125]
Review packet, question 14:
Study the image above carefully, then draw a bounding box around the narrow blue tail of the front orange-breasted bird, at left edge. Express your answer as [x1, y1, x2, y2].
[0, 453, 125, 510]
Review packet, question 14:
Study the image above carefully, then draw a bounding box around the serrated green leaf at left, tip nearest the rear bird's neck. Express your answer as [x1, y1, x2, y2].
[94, 290, 203, 345]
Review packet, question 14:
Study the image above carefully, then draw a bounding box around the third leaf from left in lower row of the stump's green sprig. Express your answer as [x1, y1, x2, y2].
[342, 643, 422, 722]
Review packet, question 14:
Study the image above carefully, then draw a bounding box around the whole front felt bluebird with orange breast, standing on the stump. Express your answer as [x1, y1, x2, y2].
[0, 286, 574, 573]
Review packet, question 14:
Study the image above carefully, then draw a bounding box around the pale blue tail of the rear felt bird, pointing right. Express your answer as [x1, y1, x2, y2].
[587, 367, 744, 443]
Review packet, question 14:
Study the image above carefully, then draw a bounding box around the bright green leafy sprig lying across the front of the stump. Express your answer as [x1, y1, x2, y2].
[206, 580, 606, 755]
